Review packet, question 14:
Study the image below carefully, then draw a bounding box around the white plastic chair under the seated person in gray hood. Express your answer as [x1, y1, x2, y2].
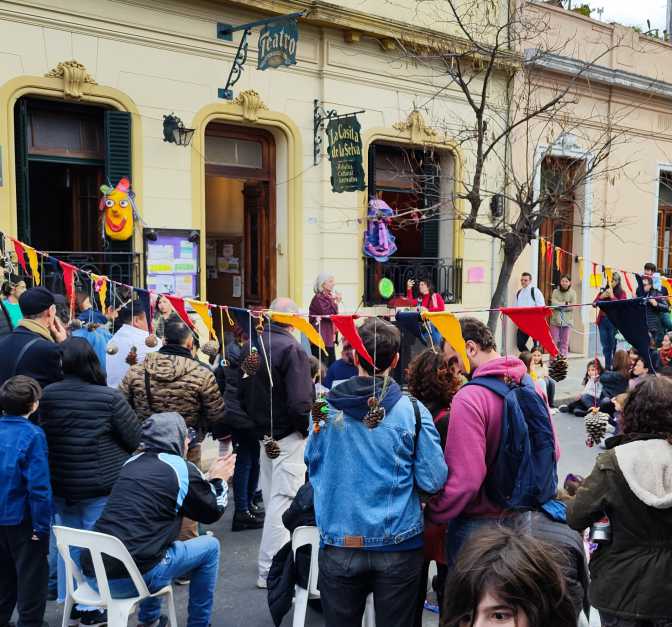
[54, 526, 177, 627]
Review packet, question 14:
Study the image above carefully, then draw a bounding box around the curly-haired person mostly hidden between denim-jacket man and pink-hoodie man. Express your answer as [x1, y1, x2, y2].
[406, 349, 463, 627]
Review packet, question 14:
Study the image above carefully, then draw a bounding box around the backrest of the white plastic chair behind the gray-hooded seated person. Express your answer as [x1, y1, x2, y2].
[54, 525, 149, 604]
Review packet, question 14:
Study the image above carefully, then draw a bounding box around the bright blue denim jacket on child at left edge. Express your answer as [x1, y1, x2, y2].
[0, 416, 52, 537]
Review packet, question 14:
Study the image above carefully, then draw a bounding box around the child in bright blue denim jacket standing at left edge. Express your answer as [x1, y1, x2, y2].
[0, 375, 51, 627]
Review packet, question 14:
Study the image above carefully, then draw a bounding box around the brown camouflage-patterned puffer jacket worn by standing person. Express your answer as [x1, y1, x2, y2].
[119, 345, 224, 435]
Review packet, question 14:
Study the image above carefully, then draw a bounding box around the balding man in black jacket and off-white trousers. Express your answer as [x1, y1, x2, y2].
[240, 298, 313, 588]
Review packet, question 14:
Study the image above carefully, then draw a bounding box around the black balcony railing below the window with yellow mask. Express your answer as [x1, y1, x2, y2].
[44, 250, 142, 291]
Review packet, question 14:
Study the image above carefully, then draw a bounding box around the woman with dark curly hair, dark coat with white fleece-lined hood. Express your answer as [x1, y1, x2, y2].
[567, 377, 672, 627]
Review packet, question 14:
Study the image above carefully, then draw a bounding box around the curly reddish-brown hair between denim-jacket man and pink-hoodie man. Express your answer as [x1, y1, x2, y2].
[406, 348, 462, 409]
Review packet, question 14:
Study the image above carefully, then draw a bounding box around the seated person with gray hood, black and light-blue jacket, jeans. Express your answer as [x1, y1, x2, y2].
[82, 412, 235, 627]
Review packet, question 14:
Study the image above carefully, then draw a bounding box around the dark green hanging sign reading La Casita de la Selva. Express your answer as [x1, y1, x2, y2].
[327, 115, 366, 193]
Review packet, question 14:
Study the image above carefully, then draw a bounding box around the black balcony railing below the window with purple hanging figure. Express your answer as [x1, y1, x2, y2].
[364, 257, 462, 306]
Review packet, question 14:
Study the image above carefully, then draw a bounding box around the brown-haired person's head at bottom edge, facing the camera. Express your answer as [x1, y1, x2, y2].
[440, 527, 576, 627]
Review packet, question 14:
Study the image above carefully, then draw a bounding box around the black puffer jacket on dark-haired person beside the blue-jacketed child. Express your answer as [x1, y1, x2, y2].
[40, 376, 140, 501]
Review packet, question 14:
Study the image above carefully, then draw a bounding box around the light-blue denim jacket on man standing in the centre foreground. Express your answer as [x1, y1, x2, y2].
[305, 390, 448, 550]
